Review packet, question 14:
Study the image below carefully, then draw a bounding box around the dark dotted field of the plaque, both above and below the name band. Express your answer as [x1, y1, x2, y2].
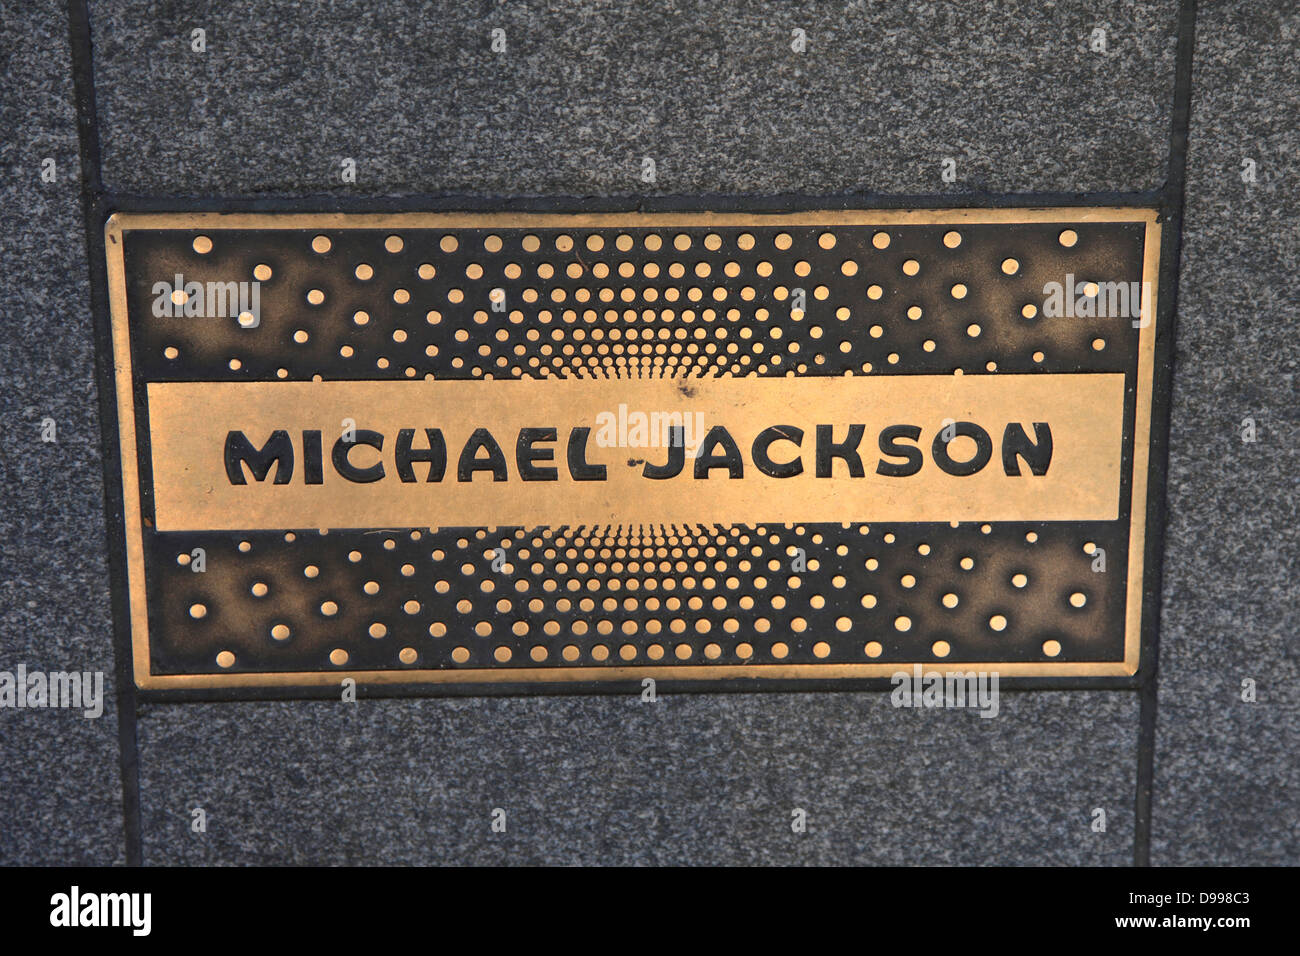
[125, 222, 1144, 674]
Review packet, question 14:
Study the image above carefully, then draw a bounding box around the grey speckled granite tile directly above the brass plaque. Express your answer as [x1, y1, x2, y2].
[91, 0, 1177, 195]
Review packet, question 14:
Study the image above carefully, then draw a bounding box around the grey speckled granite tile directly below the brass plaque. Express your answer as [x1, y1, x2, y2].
[140, 692, 1138, 865]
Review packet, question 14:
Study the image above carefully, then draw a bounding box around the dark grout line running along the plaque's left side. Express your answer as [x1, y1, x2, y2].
[68, 0, 143, 866]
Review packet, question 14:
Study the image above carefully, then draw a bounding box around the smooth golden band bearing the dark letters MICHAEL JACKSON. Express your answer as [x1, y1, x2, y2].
[148, 373, 1123, 531]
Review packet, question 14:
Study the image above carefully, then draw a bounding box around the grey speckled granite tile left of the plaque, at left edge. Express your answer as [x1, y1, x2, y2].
[0, 3, 124, 864]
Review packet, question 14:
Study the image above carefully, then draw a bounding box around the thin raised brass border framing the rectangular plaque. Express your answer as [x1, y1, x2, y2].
[103, 200, 1173, 700]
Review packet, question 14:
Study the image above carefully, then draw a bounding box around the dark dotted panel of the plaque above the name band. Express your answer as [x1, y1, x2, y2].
[126, 224, 1143, 381]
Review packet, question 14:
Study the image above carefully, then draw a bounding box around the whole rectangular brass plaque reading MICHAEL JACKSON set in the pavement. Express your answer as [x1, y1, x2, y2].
[98, 208, 1161, 692]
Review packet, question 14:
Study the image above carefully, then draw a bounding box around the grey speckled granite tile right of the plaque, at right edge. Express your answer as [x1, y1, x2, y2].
[1152, 3, 1300, 865]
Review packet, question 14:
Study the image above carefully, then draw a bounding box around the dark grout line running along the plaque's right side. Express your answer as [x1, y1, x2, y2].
[1134, 0, 1196, 866]
